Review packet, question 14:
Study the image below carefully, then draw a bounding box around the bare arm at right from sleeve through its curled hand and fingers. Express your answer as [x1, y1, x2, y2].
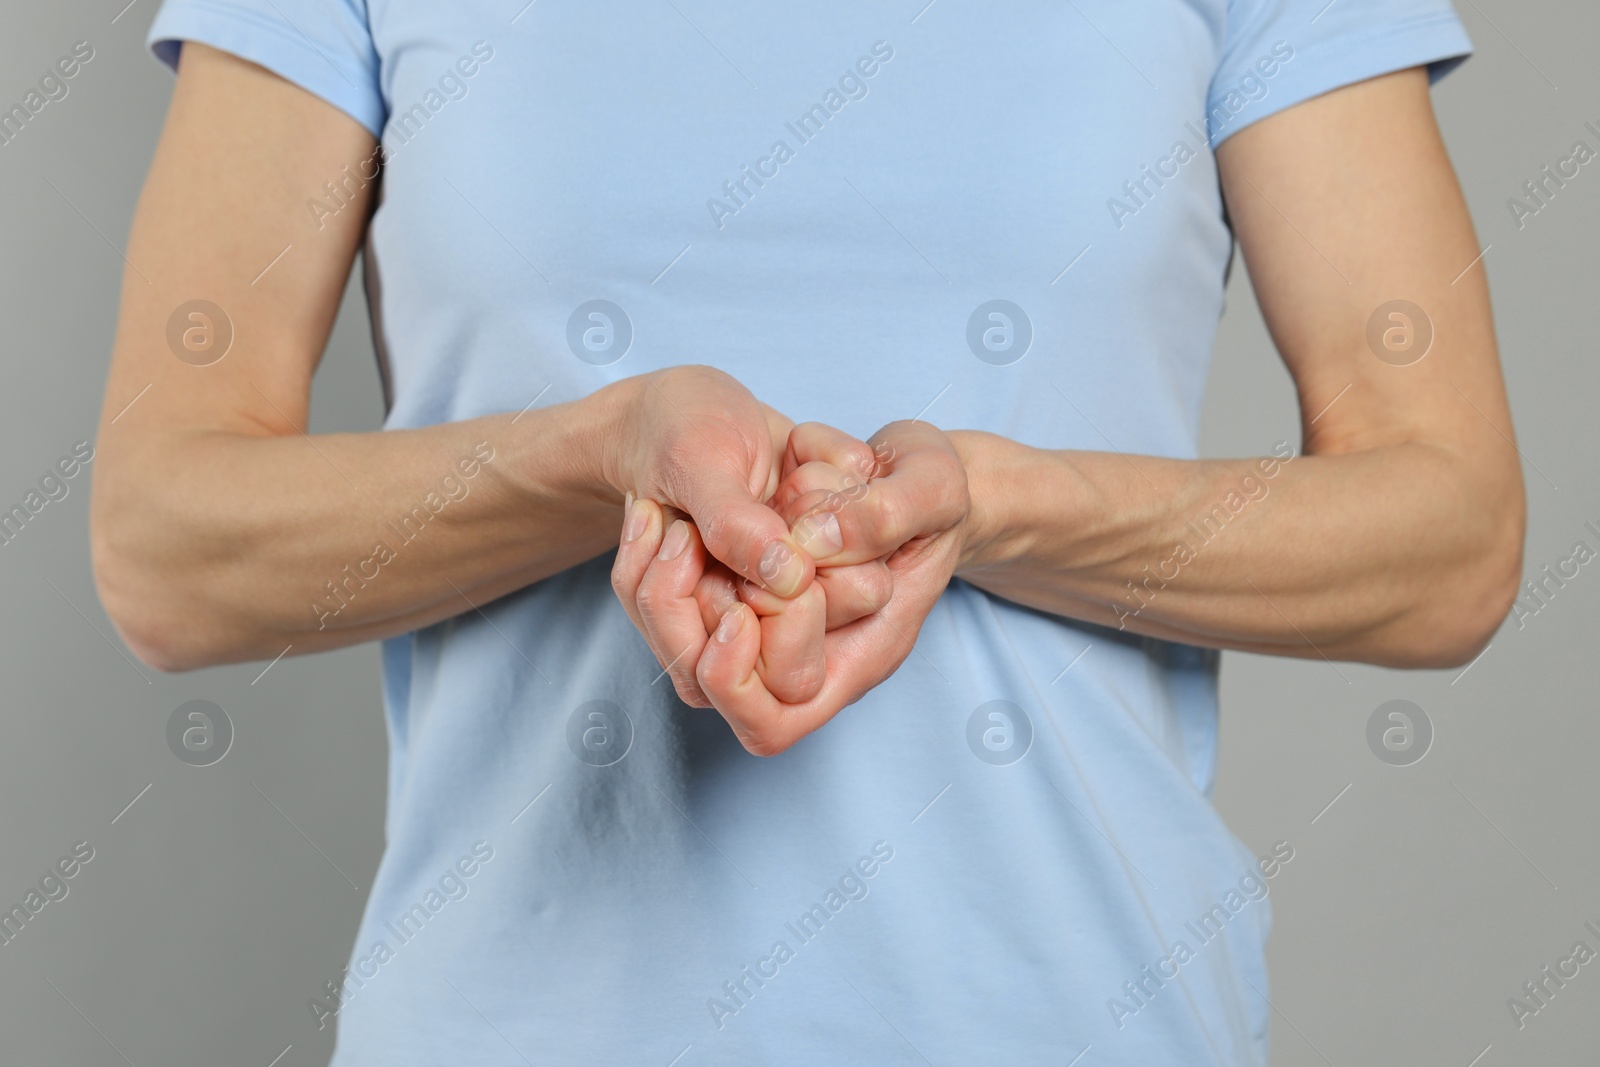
[553, 70, 1523, 755]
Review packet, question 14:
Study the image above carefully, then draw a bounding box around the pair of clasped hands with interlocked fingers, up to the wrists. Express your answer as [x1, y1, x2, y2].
[611, 366, 971, 755]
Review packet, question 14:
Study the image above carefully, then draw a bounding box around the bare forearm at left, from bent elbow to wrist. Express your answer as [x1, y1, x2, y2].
[91, 387, 622, 669]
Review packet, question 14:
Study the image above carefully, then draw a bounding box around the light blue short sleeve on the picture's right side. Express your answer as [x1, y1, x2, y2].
[1206, 0, 1472, 144]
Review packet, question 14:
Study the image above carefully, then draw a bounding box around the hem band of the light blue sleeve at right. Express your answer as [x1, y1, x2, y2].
[1210, 14, 1472, 147]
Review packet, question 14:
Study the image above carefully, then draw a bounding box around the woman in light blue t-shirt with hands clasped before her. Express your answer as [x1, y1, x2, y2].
[93, 0, 1523, 1067]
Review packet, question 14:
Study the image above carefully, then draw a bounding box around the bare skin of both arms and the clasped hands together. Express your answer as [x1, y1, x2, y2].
[91, 45, 1523, 755]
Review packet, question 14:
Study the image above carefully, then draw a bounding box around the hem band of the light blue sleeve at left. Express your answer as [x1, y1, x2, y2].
[149, 3, 386, 138]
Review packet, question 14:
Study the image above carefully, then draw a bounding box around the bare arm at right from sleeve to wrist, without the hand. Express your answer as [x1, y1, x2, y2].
[952, 69, 1525, 667]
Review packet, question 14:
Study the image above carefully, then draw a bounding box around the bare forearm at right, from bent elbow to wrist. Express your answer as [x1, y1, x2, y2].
[955, 434, 1522, 667]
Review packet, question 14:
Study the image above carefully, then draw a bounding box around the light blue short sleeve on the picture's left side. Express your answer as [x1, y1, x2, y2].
[149, 0, 387, 136]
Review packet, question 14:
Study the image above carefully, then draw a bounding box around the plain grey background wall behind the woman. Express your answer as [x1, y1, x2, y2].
[0, 0, 1600, 1067]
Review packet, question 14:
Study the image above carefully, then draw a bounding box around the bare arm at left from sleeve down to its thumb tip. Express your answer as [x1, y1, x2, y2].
[91, 43, 811, 670]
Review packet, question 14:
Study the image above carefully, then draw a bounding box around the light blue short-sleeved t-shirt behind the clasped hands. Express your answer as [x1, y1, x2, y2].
[150, 0, 1470, 1067]
